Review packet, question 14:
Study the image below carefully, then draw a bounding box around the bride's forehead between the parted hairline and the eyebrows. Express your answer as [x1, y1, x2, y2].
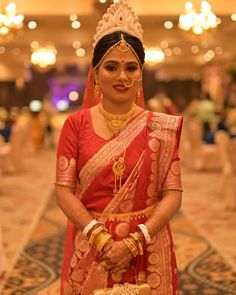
[102, 46, 139, 63]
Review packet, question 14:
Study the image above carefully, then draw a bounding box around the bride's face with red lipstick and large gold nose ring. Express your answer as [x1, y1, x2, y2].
[96, 46, 142, 103]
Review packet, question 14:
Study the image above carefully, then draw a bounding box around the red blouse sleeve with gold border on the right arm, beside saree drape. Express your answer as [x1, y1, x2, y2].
[162, 117, 183, 191]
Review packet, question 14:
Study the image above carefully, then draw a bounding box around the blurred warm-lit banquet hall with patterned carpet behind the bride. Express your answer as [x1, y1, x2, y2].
[0, 0, 236, 295]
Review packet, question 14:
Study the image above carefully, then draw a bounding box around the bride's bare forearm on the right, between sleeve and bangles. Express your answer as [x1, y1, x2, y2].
[145, 190, 182, 237]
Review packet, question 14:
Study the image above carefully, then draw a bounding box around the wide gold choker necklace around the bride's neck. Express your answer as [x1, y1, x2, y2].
[99, 103, 136, 135]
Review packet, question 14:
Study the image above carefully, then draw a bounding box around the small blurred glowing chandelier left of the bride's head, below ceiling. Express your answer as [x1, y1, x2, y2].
[31, 46, 57, 72]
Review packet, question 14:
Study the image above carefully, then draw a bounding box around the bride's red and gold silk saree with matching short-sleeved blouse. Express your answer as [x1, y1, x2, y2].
[56, 109, 182, 295]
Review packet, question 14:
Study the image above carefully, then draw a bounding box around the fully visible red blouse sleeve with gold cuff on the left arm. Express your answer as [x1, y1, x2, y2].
[55, 113, 79, 189]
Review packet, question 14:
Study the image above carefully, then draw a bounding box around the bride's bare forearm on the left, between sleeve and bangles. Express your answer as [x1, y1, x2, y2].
[56, 186, 92, 230]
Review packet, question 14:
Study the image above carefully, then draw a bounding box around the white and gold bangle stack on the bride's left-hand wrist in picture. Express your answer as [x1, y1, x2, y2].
[82, 220, 112, 252]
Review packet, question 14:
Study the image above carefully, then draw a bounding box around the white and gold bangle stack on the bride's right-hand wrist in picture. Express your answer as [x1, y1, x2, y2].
[122, 224, 151, 257]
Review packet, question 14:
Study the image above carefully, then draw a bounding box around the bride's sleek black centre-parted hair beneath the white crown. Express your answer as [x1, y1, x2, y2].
[92, 31, 145, 68]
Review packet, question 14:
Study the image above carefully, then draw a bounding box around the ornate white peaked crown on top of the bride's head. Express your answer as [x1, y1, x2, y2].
[93, 0, 143, 47]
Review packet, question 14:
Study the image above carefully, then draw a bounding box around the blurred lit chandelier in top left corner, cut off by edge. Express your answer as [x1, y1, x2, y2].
[0, 1, 24, 39]
